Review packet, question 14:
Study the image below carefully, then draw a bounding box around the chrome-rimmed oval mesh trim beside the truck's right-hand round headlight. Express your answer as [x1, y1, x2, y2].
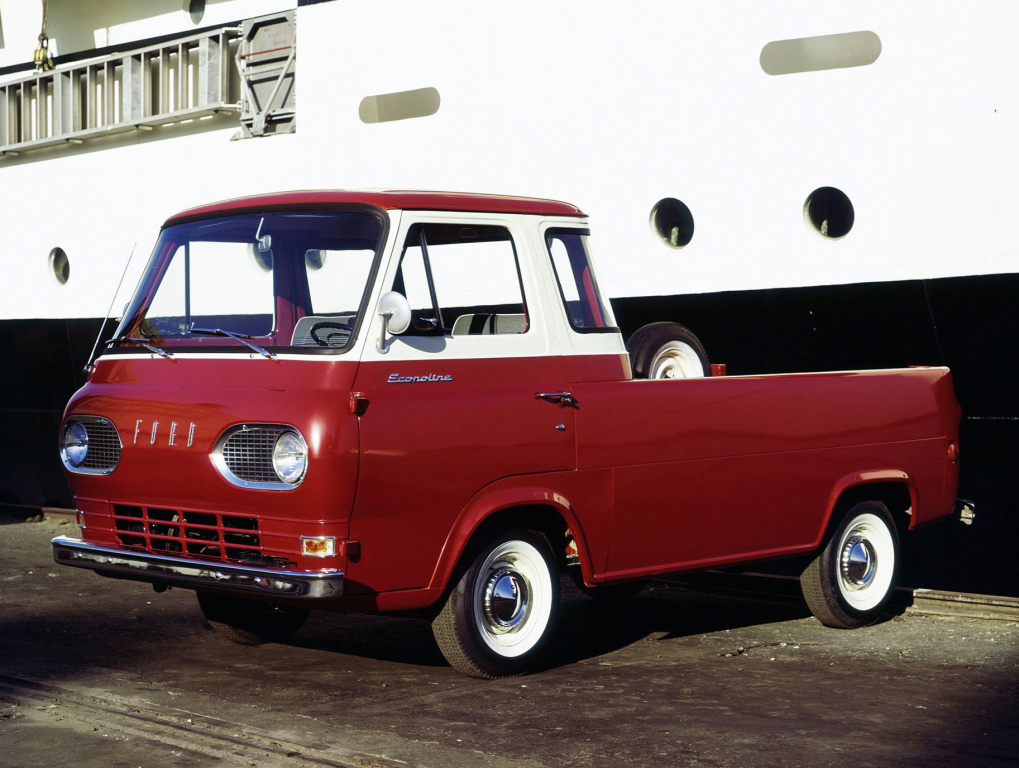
[206, 424, 307, 491]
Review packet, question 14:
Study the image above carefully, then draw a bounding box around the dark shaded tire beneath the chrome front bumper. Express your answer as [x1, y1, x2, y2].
[197, 592, 310, 646]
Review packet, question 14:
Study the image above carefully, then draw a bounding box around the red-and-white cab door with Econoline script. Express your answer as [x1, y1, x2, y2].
[347, 213, 576, 594]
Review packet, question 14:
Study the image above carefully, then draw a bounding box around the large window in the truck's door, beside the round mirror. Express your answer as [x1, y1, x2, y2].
[393, 217, 528, 336]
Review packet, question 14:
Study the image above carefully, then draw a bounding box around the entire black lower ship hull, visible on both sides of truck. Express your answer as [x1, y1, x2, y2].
[0, 275, 1019, 595]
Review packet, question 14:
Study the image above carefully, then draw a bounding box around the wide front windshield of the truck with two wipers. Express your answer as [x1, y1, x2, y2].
[110, 211, 385, 352]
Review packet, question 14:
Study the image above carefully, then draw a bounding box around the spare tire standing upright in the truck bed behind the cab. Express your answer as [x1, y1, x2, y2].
[627, 323, 711, 379]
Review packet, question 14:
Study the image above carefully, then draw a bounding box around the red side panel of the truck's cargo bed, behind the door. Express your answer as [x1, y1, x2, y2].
[573, 369, 957, 578]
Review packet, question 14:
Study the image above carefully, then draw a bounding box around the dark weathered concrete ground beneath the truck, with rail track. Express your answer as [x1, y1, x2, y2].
[0, 519, 1019, 768]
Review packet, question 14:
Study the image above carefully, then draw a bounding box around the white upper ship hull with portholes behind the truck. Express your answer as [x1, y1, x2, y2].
[0, 0, 1019, 319]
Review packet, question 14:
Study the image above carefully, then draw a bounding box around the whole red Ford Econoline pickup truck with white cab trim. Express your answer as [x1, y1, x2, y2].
[53, 191, 960, 677]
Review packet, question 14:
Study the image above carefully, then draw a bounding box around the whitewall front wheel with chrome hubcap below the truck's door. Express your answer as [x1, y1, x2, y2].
[432, 531, 559, 678]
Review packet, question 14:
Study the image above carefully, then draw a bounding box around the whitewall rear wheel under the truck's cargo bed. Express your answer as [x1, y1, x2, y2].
[800, 501, 899, 629]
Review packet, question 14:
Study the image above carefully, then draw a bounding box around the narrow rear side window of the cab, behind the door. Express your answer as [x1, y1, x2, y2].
[545, 229, 615, 332]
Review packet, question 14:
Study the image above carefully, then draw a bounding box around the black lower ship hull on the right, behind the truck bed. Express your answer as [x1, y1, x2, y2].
[612, 274, 1019, 596]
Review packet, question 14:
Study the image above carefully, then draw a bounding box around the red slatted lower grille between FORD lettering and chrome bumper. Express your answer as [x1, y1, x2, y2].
[113, 504, 268, 561]
